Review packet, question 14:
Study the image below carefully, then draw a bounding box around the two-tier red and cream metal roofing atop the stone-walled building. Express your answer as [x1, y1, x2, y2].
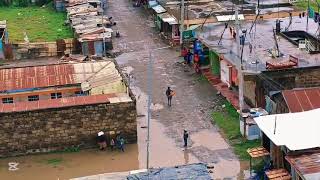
[0, 61, 132, 112]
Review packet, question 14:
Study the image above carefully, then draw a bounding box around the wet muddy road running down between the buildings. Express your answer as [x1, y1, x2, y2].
[107, 0, 240, 179]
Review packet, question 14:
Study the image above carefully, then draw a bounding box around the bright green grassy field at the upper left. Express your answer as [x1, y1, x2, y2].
[0, 6, 73, 42]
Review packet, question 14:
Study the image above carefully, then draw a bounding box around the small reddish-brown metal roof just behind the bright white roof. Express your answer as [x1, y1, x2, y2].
[282, 88, 320, 113]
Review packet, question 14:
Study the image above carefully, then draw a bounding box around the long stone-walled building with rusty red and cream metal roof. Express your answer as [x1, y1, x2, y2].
[0, 60, 137, 157]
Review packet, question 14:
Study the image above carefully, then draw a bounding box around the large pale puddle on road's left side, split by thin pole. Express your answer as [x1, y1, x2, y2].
[133, 87, 199, 169]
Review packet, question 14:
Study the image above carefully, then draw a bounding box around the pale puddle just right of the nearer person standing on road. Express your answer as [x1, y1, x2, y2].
[190, 129, 230, 150]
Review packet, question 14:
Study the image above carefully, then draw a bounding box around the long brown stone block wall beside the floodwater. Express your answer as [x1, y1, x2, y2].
[0, 101, 137, 157]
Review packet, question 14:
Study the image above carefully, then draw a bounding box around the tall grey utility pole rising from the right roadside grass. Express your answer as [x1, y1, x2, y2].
[235, 5, 247, 137]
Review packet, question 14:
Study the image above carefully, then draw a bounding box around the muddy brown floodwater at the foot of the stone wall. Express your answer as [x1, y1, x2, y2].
[0, 144, 139, 180]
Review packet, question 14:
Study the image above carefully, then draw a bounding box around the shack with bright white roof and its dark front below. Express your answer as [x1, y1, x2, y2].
[254, 109, 320, 172]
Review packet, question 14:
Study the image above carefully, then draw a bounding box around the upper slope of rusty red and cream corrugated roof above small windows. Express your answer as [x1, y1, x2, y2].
[0, 61, 113, 91]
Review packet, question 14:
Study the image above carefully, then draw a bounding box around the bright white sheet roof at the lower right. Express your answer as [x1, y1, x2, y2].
[254, 108, 320, 151]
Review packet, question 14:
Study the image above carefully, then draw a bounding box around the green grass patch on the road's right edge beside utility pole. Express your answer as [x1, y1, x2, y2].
[212, 101, 261, 161]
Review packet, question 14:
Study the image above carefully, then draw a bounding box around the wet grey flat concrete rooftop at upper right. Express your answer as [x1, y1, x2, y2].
[198, 17, 320, 72]
